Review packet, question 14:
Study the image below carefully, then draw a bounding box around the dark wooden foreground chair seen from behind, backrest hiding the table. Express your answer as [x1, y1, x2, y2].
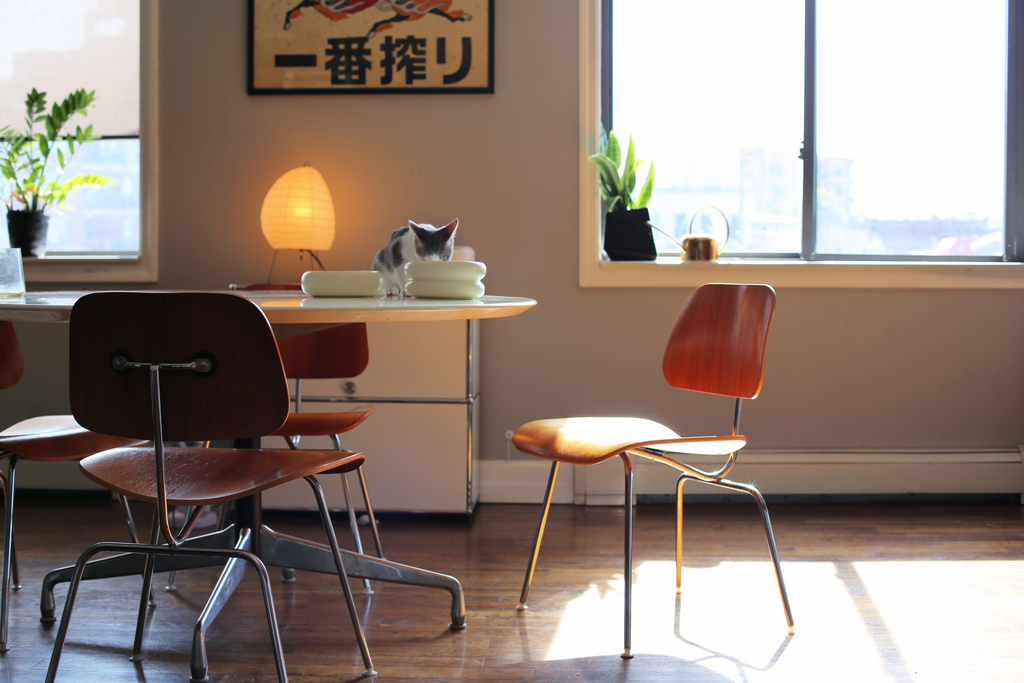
[46, 292, 375, 683]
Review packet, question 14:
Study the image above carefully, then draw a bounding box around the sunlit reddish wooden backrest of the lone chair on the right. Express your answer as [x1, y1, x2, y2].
[662, 284, 775, 398]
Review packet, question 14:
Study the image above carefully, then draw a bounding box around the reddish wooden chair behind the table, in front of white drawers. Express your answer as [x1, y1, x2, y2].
[231, 283, 384, 569]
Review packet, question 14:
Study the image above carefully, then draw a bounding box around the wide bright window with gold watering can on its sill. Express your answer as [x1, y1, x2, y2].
[581, 0, 1024, 287]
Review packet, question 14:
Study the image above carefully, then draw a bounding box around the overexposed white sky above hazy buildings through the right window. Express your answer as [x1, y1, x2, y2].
[613, 0, 1007, 219]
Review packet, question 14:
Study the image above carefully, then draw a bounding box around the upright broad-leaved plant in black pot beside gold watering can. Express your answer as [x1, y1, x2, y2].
[590, 127, 657, 261]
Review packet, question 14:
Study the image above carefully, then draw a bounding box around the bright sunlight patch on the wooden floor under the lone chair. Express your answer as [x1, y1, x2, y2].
[545, 561, 1024, 681]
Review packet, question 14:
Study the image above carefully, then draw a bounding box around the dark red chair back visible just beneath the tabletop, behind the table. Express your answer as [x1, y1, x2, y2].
[238, 283, 370, 380]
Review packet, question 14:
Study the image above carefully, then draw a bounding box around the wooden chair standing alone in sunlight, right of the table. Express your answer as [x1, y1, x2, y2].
[512, 285, 794, 658]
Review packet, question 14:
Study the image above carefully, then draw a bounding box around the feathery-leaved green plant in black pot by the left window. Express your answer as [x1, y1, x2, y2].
[0, 88, 110, 257]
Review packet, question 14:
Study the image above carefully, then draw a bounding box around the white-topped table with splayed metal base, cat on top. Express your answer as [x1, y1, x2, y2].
[0, 290, 537, 680]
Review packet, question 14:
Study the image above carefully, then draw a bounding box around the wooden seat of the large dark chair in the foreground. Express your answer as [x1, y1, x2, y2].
[79, 447, 364, 505]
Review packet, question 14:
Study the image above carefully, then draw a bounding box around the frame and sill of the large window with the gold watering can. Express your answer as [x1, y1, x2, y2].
[579, 0, 1024, 289]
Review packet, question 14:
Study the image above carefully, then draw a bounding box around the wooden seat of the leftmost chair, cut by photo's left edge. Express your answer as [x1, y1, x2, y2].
[0, 415, 145, 463]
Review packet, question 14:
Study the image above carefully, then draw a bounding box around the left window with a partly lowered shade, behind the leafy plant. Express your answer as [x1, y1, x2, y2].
[0, 0, 157, 282]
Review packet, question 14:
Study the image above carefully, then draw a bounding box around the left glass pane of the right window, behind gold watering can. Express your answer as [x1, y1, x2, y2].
[612, 0, 804, 253]
